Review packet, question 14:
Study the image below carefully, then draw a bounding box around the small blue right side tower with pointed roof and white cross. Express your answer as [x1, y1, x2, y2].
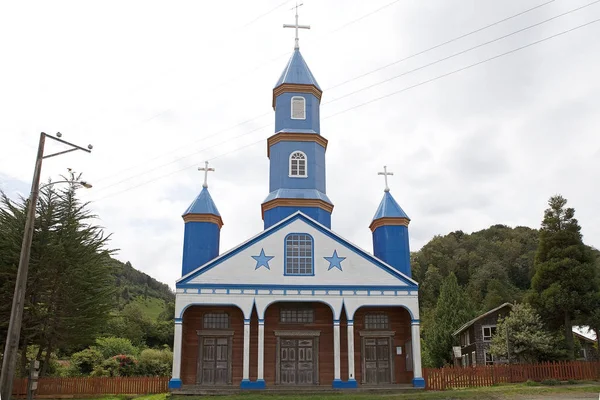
[369, 167, 411, 277]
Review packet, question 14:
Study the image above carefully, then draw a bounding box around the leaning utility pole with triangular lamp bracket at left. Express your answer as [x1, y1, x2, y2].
[0, 132, 92, 400]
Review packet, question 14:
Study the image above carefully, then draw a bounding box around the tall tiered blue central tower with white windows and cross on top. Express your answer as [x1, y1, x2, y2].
[261, 16, 333, 229]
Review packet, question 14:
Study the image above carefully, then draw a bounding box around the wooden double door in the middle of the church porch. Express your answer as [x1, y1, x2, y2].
[279, 339, 316, 385]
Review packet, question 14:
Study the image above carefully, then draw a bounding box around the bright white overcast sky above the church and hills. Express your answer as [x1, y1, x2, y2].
[0, 0, 600, 286]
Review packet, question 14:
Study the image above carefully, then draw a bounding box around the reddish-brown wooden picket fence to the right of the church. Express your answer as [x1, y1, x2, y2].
[423, 361, 600, 390]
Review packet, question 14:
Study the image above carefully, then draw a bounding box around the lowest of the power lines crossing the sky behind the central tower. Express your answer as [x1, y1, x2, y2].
[89, 18, 600, 202]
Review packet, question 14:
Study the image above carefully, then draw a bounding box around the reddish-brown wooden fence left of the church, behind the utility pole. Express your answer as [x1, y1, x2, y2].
[13, 376, 169, 397]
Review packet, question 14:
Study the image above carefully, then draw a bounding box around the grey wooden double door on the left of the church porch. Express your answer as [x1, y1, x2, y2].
[198, 337, 231, 385]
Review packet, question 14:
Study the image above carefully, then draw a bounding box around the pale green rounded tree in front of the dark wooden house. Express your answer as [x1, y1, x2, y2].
[490, 304, 555, 364]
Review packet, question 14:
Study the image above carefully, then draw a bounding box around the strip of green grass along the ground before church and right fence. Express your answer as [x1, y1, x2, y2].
[77, 382, 600, 400]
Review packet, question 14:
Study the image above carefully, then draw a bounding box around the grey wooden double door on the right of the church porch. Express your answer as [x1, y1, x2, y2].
[363, 338, 392, 385]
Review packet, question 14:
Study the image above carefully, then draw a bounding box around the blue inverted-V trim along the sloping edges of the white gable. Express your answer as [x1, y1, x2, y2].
[176, 213, 418, 290]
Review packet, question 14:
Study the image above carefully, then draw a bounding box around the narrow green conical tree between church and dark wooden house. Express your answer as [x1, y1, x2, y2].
[424, 273, 473, 367]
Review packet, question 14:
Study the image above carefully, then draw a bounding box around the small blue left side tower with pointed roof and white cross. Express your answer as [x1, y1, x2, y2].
[181, 161, 223, 276]
